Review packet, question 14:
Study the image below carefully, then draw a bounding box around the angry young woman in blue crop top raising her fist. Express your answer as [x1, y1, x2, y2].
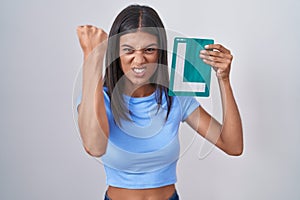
[77, 5, 243, 200]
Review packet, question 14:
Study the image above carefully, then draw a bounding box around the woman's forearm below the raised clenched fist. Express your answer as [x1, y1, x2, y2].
[78, 47, 109, 157]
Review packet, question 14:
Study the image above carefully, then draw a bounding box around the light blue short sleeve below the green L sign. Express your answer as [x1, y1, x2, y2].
[177, 96, 200, 122]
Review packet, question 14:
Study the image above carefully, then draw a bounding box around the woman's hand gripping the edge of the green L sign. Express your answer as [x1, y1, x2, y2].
[200, 44, 233, 80]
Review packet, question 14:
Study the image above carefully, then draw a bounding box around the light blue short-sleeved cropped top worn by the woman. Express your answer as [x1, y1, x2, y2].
[76, 88, 199, 189]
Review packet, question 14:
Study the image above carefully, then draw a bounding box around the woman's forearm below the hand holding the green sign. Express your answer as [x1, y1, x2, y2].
[219, 79, 243, 155]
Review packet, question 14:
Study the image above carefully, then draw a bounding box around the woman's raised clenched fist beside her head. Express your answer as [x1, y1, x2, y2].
[77, 25, 107, 58]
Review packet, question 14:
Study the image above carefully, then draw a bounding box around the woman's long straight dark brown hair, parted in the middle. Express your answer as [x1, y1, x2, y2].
[104, 5, 172, 122]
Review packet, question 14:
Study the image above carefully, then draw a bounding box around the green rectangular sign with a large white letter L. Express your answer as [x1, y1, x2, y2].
[169, 37, 214, 97]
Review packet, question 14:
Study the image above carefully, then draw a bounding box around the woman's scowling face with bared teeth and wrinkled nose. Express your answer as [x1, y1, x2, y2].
[120, 31, 158, 86]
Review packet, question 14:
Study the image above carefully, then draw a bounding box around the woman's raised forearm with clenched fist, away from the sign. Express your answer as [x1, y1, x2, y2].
[77, 25, 109, 157]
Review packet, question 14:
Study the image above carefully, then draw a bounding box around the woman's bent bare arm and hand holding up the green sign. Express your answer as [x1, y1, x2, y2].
[186, 44, 243, 156]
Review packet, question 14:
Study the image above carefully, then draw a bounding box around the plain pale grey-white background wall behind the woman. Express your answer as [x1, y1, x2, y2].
[0, 0, 300, 200]
